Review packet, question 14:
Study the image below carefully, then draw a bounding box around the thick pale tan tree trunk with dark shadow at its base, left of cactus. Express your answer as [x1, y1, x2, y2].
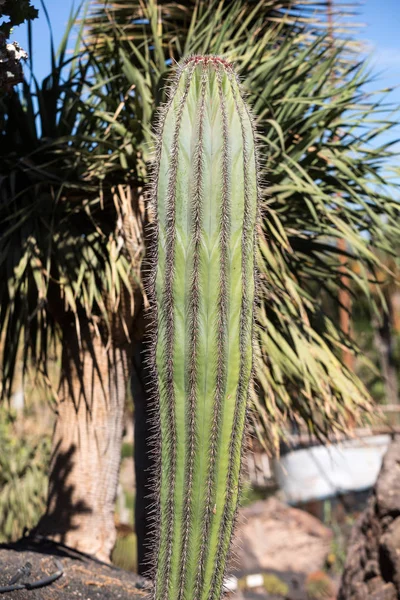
[37, 323, 131, 561]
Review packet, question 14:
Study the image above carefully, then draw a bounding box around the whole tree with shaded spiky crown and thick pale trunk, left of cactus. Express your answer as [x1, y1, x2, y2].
[0, 15, 143, 559]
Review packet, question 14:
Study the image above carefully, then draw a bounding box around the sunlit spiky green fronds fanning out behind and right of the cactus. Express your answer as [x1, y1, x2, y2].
[79, 2, 399, 445]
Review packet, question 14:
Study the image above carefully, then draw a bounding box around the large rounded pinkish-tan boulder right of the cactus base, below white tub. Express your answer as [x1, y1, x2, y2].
[234, 498, 332, 573]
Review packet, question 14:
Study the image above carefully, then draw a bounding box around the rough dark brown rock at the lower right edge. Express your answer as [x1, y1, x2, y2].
[338, 437, 400, 600]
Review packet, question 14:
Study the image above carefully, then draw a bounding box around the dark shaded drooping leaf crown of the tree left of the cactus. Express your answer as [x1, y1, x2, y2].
[0, 14, 142, 396]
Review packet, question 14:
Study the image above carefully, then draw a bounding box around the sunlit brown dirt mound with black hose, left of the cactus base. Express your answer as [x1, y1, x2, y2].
[0, 540, 149, 600]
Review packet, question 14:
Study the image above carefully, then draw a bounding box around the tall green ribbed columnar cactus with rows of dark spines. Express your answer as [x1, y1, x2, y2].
[150, 56, 258, 600]
